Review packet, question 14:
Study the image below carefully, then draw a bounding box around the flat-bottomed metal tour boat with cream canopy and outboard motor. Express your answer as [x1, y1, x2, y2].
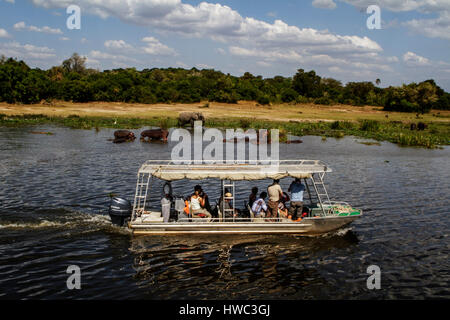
[109, 160, 362, 235]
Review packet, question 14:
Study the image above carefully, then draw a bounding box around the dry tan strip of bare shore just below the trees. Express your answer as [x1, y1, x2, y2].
[0, 101, 450, 122]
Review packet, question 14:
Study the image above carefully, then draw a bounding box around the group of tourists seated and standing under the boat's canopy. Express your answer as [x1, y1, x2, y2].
[178, 178, 305, 221]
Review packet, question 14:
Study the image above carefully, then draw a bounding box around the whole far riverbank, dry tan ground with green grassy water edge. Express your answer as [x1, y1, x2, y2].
[0, 102, 450, 148]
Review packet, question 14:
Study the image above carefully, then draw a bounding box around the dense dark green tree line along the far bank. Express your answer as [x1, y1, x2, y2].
[0, 54, 450, 113]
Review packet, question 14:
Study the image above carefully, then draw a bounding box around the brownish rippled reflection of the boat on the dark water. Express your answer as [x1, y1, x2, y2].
[130, 230, 358, 299]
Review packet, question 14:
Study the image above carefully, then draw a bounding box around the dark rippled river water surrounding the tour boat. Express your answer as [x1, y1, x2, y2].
[0, 126, 450, 299]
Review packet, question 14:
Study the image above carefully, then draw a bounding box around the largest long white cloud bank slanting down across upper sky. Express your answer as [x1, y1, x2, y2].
[32, 0, 381, 52]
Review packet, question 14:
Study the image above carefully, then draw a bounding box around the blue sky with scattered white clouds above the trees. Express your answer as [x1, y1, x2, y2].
[0, 0, 450, 92]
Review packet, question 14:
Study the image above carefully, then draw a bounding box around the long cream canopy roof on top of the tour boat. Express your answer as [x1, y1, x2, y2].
[139, 160, 332, 181]
